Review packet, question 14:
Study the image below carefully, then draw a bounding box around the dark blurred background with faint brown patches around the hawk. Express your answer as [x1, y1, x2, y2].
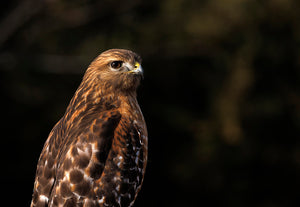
[0, 0, 300, 207]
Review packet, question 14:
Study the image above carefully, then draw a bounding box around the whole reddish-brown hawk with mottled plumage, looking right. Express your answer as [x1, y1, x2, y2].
[31, 49, 148, 207]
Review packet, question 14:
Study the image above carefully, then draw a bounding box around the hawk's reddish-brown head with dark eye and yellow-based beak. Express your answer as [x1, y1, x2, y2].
[84, 49, 143, 91]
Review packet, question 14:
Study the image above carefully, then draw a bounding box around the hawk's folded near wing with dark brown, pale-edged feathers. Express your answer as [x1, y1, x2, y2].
[49, 111, 121, 206]
